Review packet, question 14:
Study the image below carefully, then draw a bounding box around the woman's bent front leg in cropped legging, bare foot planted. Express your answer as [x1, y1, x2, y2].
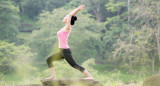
[46, 52, 64, 80]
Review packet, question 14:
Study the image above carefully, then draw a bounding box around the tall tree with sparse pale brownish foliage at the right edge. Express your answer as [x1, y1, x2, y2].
[112, 0, 158, 72]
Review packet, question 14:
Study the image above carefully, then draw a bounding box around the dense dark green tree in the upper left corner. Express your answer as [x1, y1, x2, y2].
[0, 0, 19, 42]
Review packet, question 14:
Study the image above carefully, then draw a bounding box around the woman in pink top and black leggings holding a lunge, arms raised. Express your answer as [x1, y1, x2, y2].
[45, 5, 94, 80]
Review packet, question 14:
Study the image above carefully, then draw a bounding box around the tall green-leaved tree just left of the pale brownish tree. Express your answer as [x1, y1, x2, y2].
[101, 0, 129, 65]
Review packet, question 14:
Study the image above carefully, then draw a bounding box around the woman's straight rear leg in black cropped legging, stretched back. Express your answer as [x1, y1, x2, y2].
[62, 49, 94, 79]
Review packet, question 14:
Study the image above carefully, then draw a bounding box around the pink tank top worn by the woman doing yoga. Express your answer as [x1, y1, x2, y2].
[57, 29, 71, 49]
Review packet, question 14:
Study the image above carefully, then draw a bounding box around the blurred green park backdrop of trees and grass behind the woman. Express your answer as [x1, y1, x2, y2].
[0, 0, 160, 86]
